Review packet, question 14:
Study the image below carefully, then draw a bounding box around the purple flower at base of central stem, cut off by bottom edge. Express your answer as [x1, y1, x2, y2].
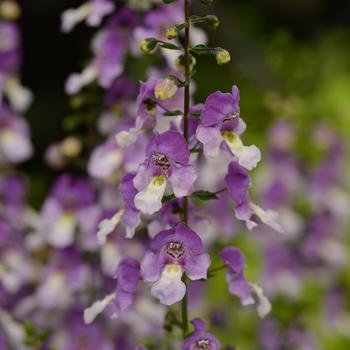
[181, 318, 221, 350]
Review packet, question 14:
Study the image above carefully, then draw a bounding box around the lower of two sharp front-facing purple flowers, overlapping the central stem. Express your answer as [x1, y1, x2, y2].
[141, 223, 210, 305]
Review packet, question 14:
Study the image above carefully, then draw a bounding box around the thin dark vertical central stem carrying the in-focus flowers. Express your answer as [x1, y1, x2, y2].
[181, 0, 191, 339]
